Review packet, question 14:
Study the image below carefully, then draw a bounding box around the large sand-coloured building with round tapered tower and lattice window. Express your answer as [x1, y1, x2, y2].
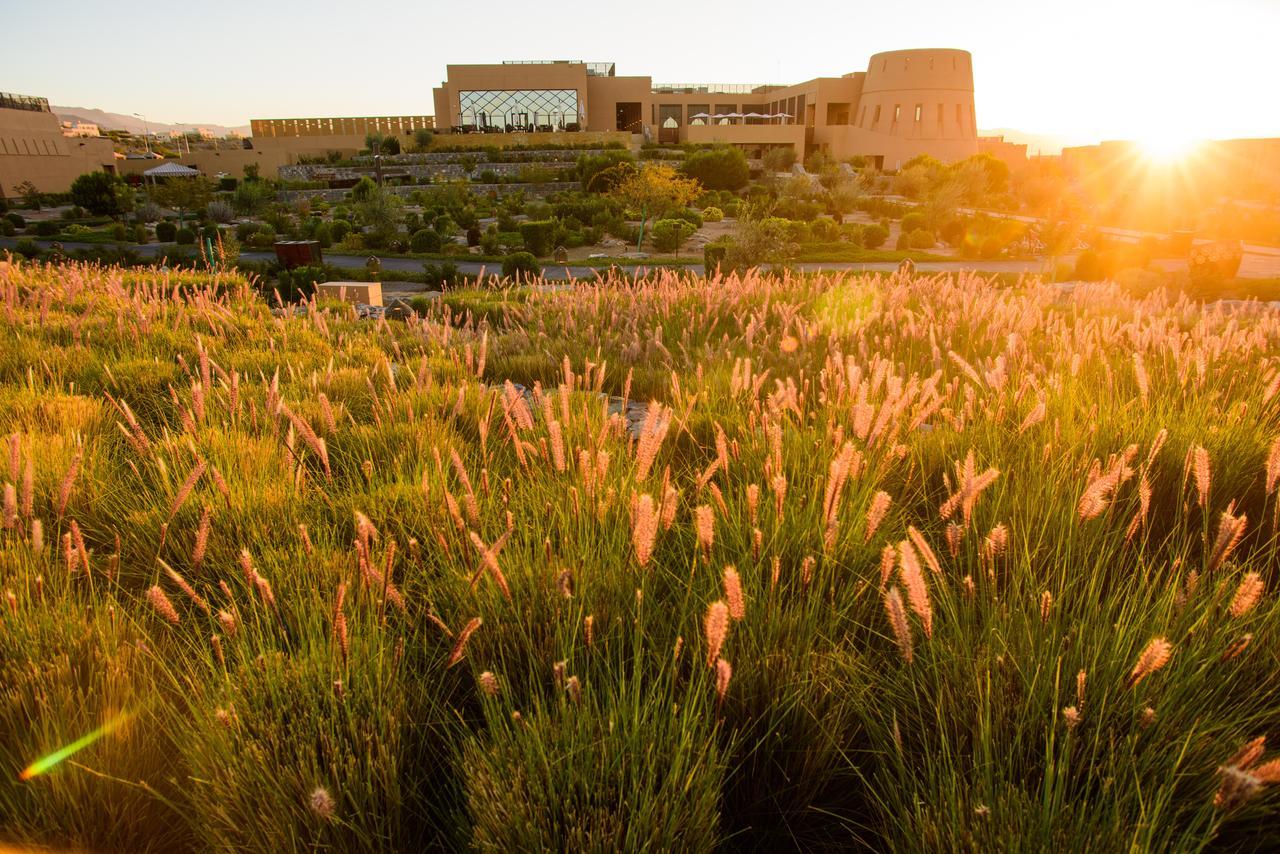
[434, 49, 978, 169]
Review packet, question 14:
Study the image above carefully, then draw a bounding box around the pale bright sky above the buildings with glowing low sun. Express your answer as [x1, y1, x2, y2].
[0, 0, 1280, 143]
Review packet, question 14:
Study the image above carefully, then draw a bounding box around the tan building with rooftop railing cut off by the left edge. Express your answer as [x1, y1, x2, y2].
[0, 92, 115, 196]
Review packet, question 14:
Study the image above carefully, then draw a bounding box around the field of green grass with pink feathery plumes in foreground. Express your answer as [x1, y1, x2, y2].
[0, 265, 1280, 851]
